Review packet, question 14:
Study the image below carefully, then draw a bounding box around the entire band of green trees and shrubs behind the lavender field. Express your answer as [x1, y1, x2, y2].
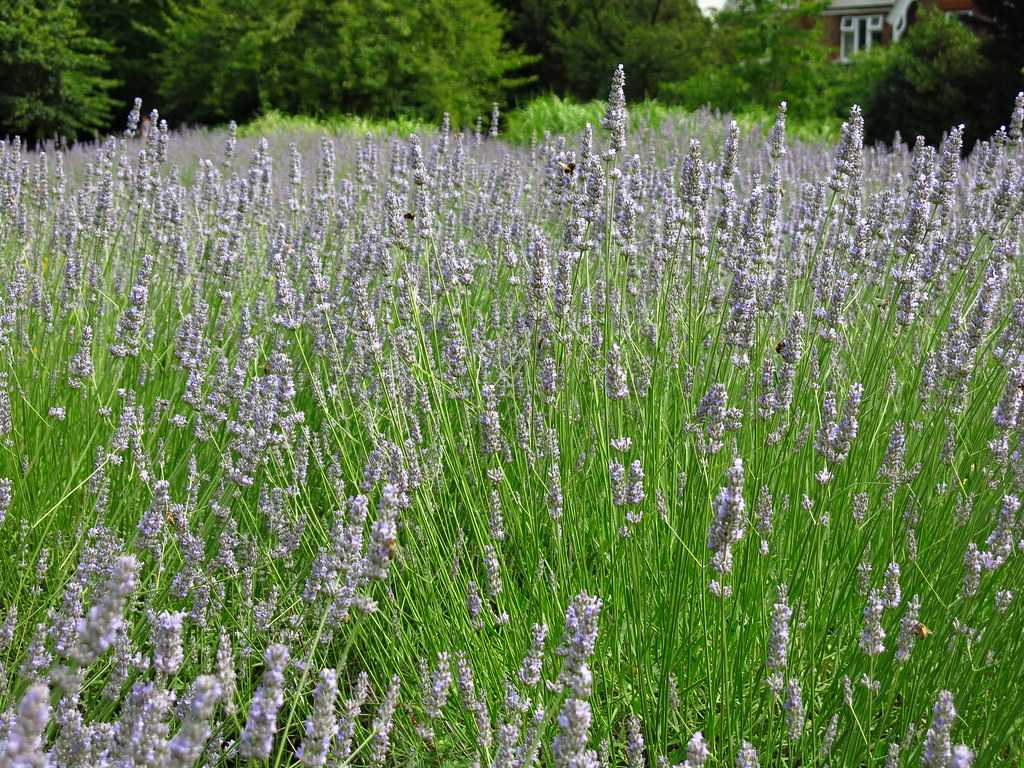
[0, 0, 1024, 143]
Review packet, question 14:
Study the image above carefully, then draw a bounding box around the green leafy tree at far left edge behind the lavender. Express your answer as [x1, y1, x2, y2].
[0, 0, 116, 140]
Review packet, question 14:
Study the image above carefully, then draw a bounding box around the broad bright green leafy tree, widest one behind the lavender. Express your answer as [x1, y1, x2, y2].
[162, 0, 526, 122]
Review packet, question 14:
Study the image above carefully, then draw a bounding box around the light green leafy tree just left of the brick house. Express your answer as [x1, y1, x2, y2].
[664, 0, 838, 117]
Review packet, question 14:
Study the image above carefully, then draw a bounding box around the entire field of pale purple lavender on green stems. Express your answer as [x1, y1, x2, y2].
[0, 69, 1024, 768]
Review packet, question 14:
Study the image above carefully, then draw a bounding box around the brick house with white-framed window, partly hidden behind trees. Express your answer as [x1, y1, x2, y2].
[824, 0, 974, 61]
